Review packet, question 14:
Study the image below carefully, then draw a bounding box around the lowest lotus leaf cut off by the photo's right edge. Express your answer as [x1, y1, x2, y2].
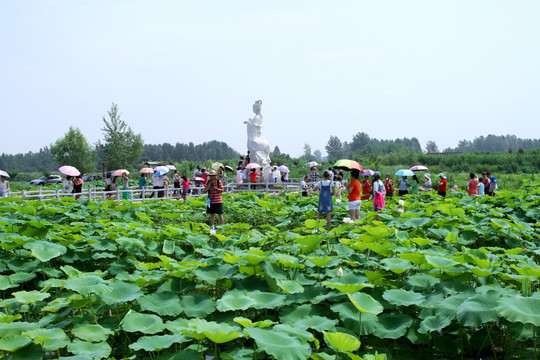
[497, 296, 540, 326]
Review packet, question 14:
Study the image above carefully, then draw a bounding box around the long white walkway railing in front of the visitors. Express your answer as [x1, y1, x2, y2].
[2, 179, 301, 202]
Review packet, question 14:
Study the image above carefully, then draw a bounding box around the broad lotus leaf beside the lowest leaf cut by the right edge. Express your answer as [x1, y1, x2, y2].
[456, 290, 500, 327]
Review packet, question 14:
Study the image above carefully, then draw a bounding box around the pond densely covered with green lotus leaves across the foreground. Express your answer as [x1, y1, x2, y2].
[0, 183, 540, 359]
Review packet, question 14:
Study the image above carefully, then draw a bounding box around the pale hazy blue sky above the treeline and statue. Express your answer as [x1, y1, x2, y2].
[0, 0, 540, 156]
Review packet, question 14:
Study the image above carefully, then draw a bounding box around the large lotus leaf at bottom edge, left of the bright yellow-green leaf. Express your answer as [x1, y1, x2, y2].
[245, 327, 311, 360]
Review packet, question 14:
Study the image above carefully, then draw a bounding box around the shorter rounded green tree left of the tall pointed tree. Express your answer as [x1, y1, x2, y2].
[50, 126, 97, 174]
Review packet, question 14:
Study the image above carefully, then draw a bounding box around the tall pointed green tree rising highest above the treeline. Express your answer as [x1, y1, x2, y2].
[98, 103, 144, 169]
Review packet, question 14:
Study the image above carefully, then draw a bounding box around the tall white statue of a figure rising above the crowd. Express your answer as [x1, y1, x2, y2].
[244, 100, 271, 179]
